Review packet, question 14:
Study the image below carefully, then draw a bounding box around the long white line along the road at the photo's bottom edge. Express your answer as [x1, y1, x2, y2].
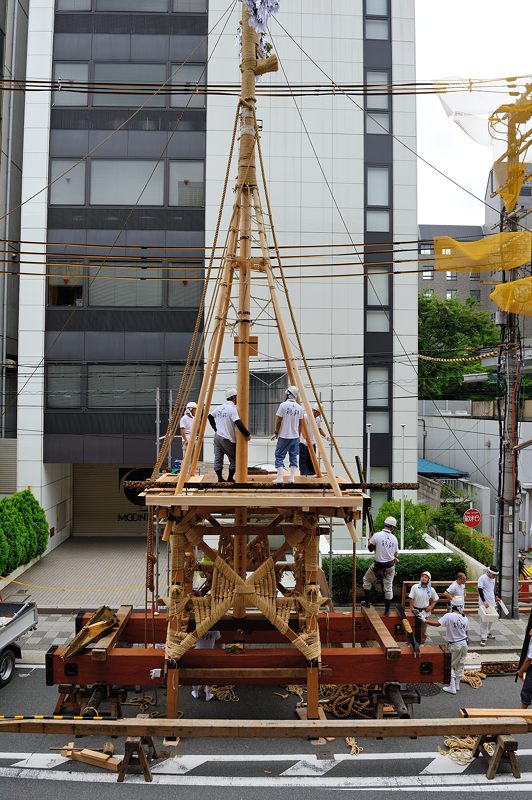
[0, 767, 532, 797]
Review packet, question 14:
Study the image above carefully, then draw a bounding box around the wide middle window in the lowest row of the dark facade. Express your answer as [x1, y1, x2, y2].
[87, 364, 161, 409]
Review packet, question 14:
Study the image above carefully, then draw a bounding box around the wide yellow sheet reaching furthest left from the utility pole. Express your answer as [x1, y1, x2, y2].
[434, 231, 532, 272]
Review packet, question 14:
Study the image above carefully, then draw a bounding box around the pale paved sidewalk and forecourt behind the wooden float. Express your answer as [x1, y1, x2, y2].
[2, 537, 528, 663]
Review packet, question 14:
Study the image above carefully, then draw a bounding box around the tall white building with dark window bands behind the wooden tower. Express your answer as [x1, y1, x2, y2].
[17, 0, 417, 542]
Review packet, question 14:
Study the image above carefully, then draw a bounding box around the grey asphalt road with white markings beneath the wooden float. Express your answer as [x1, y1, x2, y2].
[0, 665, 532, 800]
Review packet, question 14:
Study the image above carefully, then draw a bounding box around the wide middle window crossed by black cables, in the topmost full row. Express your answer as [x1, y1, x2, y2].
[92, 64, 167, 107]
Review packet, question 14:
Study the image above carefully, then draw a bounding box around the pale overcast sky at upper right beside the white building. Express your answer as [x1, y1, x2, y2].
[416, 0, 532, 225]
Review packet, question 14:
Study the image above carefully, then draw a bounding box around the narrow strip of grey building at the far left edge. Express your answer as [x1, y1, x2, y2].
[0, 0, 28, 495]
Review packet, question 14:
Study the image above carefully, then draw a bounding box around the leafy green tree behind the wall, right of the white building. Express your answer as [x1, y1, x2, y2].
[418, 294, 500, 400]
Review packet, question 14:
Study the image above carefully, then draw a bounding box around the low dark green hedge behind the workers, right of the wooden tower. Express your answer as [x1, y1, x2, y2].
[322, 553, 466, 605]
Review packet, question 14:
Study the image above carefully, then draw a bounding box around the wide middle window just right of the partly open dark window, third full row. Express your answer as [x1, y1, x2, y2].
[89, 260, 162, 307]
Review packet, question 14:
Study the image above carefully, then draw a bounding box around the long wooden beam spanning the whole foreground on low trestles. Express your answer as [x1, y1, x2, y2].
[0, 717, 532, 739]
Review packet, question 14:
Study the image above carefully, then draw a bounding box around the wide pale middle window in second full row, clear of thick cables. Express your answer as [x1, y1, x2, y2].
[90, 159, 164, 206]
